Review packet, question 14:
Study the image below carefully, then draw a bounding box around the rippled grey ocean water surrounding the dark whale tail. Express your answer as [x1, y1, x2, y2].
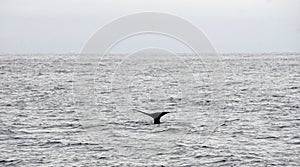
[0, 53, 300, 166]
